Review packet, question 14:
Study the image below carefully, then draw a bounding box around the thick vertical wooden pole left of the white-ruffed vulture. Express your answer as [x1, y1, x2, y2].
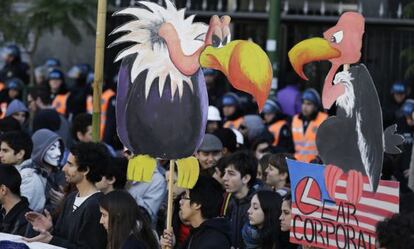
[92, 0, 106, 142]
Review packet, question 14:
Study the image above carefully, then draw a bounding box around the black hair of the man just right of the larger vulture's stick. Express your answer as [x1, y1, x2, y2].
[190, 175, 223, 219]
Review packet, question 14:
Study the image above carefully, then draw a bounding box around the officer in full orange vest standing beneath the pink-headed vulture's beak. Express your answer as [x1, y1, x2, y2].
[292, 88, 328, 162]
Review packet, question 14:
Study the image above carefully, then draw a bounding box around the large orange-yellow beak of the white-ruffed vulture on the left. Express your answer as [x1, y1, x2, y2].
[200, 40, 273, 110]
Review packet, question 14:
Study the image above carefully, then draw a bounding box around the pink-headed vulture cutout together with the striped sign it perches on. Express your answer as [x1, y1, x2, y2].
[288, 12, 403, 248]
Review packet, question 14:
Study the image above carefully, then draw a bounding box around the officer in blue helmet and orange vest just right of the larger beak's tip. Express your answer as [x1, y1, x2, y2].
[261, 99, 295, 152]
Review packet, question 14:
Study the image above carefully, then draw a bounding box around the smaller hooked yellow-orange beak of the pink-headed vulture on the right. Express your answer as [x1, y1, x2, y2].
[288, 38, 341, 80]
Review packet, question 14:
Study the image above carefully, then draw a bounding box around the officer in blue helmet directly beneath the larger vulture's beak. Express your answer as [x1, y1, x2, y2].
[222, 92, 243, 129]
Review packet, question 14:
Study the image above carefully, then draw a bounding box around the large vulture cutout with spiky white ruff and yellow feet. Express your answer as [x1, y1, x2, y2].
[112, 0, 272, 188]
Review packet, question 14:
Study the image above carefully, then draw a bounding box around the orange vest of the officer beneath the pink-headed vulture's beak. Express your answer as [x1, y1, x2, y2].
[292, 112, 328, 162]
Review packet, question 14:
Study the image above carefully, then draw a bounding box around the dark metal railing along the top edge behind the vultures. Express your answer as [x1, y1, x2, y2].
[112, 0, 410, 19]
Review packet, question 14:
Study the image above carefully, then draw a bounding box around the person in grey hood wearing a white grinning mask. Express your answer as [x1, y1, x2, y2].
[32, 129, 65, 212]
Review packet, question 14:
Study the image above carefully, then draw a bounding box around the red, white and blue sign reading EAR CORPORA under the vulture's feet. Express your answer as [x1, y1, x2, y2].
[287, 160, 399, 249]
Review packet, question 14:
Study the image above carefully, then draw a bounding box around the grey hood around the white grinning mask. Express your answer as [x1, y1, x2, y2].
[32, 129, 63, 168]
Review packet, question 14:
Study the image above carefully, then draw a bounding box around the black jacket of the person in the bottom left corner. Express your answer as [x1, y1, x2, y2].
[0, 197, 31, 236]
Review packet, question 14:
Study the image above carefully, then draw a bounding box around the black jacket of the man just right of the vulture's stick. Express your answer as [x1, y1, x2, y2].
[181, 218, 230, 249]
